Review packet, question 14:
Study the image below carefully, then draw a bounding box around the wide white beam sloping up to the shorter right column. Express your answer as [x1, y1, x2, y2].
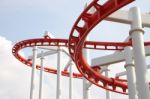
[92, 46, 150, 66]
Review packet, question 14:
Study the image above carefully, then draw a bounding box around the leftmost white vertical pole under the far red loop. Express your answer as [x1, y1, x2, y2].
[30, 46, 37, 99]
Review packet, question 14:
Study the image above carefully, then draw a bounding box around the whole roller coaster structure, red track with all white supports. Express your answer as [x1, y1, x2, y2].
[12, 0, 150, 99]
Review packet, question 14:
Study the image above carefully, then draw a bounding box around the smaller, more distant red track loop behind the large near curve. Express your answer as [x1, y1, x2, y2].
[12, 38, 131, 78]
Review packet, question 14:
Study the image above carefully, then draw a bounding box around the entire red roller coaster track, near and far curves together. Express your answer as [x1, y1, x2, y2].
[12, 0, 150, 94]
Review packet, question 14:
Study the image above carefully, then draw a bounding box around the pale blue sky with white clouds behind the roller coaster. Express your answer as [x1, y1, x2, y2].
[0, 0, 150, 99]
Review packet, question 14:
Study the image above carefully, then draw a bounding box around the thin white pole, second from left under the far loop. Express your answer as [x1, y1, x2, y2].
[39, 51, 44, 99]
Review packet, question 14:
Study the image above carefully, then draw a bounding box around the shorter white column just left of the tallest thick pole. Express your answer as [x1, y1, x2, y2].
[124, 47, 138, 99]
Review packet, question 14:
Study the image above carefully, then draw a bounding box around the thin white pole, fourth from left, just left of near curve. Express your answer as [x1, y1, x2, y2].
[69, 63, 73, 99]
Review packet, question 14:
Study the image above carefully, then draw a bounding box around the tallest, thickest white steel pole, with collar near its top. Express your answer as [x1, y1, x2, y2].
[129, 7, 150, 99]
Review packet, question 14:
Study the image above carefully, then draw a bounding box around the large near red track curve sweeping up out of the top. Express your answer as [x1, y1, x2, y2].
[69, 0, 134, 94]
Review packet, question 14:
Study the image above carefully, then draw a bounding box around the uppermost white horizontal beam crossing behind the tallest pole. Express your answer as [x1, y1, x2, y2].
[105, 10, 150, 28]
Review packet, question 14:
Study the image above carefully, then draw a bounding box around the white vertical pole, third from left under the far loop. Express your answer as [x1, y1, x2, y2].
[56, 47, 61, 99]
